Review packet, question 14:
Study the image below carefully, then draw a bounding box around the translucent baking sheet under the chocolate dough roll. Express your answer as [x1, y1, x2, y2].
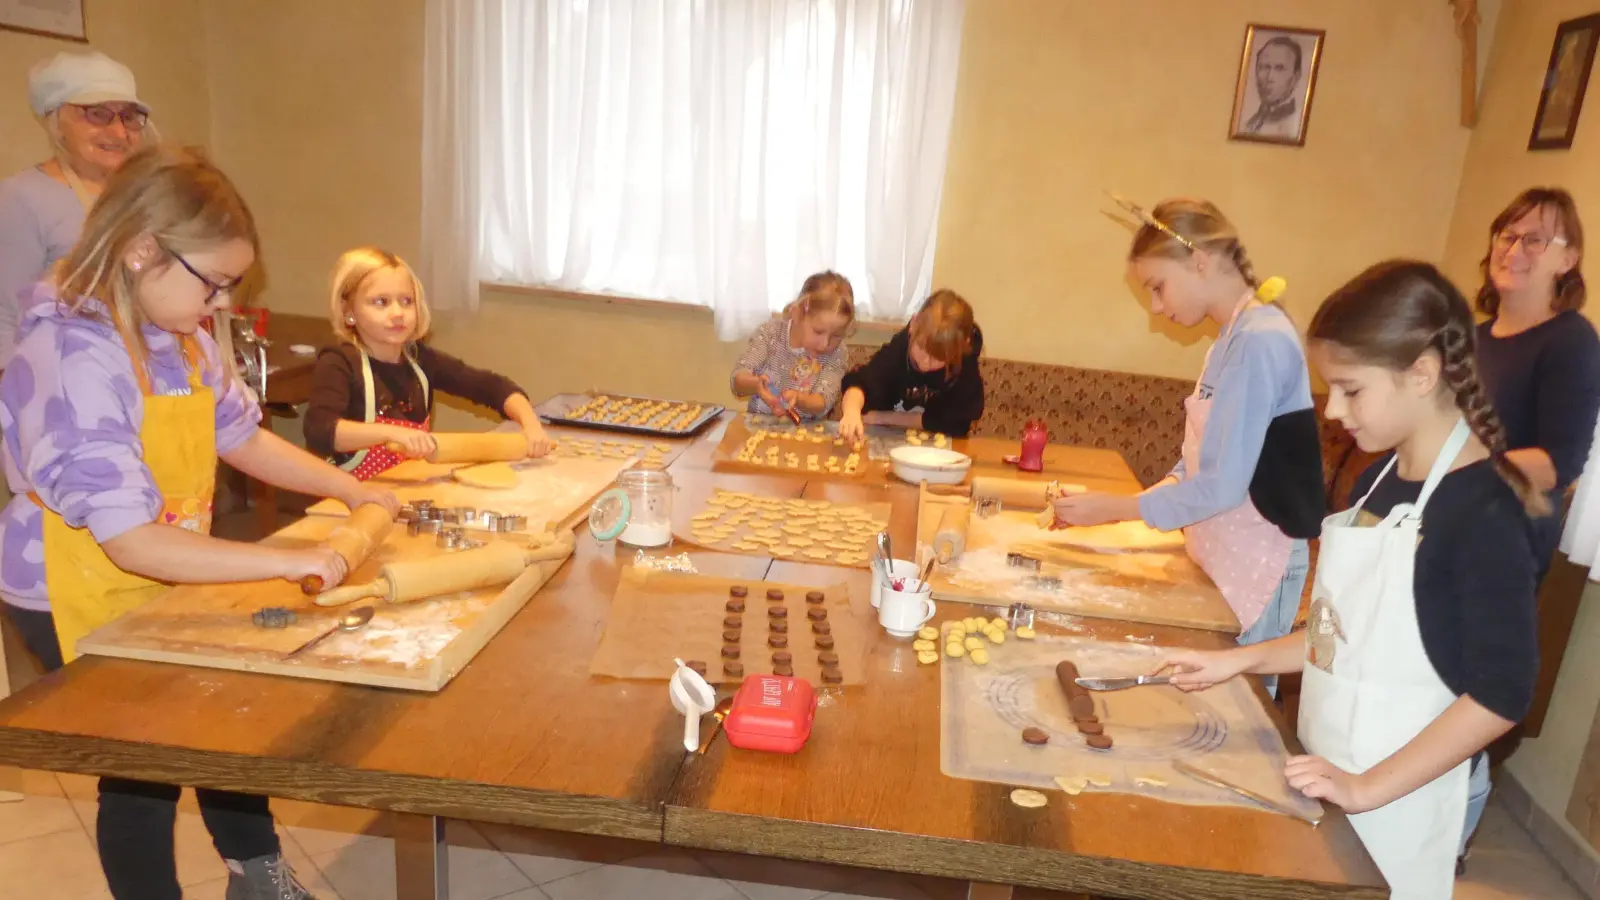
[939, 626, 1322, 822]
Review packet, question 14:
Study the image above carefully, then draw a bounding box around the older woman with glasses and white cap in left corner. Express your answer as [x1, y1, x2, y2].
[0, 53, 155, 368]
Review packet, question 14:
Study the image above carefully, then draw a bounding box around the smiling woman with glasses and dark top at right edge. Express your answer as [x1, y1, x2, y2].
[1477, 187, 1600, 573]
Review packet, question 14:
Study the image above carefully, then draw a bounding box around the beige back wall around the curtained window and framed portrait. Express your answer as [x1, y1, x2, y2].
[211, 0, 1494, 432]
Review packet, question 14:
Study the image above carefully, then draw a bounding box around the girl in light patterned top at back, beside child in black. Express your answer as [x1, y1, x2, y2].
[731, 272, 856, 418]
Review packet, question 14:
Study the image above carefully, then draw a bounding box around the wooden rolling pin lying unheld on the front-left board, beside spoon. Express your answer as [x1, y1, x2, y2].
[317, 533, 573, 607]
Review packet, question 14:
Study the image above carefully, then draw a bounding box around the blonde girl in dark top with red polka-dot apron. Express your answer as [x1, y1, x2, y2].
[304, 247, 550, 480]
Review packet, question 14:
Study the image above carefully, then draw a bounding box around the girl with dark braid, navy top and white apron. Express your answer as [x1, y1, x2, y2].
[1163, 261, 1549, 900]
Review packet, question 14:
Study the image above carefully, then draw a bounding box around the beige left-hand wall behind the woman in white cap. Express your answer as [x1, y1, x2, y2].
[0, 0, 211, 178]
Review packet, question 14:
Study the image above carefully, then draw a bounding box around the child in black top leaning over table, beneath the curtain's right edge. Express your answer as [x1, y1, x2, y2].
[838, 290, 984, 442]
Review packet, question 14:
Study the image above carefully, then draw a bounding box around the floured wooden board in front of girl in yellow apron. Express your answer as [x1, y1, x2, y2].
[78, 516, 565, 690]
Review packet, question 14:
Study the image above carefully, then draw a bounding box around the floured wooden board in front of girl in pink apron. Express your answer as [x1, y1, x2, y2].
[917, 492, 1238, 634]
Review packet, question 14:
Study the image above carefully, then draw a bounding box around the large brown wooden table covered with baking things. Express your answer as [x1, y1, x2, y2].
[0, 425, 1387, 900]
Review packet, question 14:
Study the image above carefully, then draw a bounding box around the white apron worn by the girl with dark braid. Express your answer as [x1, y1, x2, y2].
[1299, 421, 1472, 900]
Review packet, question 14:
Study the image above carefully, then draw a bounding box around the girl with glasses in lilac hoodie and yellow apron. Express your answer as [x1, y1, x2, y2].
[0, 147, 398, 900]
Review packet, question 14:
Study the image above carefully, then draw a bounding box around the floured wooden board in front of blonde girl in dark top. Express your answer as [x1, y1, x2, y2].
[307, 448, 634, 532]
